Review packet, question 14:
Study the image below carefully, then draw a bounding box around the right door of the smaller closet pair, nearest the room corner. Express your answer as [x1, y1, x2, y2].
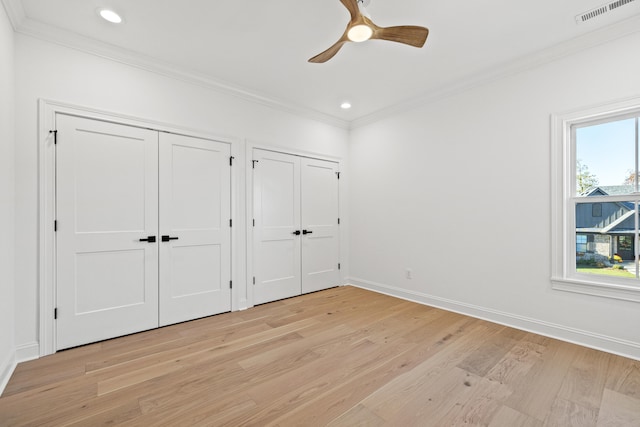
[301, 157, 340, 293]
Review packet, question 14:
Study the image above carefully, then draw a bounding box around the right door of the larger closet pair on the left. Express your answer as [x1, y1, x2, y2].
[159, 133, 231, 326]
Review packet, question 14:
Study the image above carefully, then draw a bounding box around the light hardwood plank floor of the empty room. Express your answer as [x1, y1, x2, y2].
[0, 287, 640, 427]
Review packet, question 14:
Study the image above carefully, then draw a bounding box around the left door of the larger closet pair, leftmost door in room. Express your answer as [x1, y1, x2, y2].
[56, 114, 158, 349]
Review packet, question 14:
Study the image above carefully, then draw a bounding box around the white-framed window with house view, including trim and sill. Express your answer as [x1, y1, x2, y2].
[551, 99, 640, 301]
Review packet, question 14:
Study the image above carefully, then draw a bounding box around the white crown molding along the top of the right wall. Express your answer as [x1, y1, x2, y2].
[350, 15, 640, 129]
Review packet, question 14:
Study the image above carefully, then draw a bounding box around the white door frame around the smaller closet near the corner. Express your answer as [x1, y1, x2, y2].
[244, 140, 348, 308]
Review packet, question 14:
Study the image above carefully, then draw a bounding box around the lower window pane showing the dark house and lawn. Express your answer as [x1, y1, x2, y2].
[575, 201, 637, 278]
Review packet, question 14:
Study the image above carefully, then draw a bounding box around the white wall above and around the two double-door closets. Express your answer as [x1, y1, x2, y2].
[16, 35, 348, 356]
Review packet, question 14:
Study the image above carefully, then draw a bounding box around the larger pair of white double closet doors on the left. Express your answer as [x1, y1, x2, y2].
[56, 114, 231, 349]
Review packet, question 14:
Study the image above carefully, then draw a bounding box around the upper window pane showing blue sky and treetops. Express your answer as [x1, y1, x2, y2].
[576, 118, 637, 196]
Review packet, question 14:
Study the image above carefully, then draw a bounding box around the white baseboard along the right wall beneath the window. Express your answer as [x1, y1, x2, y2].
[348, 277, 640, 360]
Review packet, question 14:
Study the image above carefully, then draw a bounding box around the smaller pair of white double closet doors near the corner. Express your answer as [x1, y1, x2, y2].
[253, 149, 339, 304]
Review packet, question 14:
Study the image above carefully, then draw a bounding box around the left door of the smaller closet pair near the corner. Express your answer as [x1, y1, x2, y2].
[253, 149, 301, 304]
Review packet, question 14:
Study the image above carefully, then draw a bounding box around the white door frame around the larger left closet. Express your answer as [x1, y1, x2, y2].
[38, 98, 246, 358]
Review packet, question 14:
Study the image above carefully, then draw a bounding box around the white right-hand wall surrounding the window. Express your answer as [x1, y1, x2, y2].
[349, 33, 640, 359]
